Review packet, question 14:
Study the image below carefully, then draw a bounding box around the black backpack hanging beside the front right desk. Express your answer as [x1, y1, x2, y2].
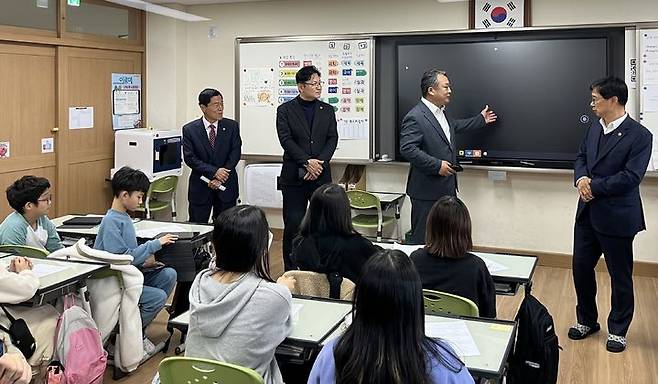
[507, 292, 561, 384]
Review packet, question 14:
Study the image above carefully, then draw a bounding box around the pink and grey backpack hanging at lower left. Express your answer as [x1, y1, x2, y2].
[54, 294, 107, 384]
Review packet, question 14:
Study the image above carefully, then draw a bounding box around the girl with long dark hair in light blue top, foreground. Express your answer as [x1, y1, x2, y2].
[308, 250, 473, 384]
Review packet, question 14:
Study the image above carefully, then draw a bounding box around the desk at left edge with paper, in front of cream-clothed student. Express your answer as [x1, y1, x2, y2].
[0, 255, 108, 313]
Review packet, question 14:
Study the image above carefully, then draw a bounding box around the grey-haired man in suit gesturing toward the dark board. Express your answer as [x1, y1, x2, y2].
[400, 69, 496, 244]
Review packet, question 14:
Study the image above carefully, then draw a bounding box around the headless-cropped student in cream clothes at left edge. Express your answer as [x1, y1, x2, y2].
[0, 256, 59, 383]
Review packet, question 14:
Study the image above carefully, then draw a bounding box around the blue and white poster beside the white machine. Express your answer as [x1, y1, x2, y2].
[111, 73, 142, 131]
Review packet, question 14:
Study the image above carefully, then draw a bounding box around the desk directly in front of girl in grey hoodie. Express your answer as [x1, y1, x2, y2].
[167, 296, 352, 356]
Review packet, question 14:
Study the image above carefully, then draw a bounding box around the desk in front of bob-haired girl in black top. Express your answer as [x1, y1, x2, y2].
[373, 243, 537, 295]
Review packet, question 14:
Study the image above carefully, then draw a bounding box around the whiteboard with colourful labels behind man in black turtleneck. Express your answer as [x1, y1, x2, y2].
[236, 37, 374, 160]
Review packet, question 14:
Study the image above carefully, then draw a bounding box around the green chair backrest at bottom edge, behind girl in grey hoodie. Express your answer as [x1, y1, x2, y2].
[158, 357, 263, 384]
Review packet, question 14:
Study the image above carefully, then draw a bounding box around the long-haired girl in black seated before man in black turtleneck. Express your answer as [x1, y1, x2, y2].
[292, 184, 381, 283]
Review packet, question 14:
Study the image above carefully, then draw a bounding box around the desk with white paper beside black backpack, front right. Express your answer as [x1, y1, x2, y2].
[321, 315, 516, 382]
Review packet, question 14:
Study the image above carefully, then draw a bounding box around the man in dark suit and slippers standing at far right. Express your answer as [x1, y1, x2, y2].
[569, 77, 652, 352]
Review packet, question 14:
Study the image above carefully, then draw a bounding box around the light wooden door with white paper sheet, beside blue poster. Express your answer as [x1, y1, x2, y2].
[57, 47, 142, 214]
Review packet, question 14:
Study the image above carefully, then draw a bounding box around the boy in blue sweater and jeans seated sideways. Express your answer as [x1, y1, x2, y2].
[94, 167, 176, 356]
